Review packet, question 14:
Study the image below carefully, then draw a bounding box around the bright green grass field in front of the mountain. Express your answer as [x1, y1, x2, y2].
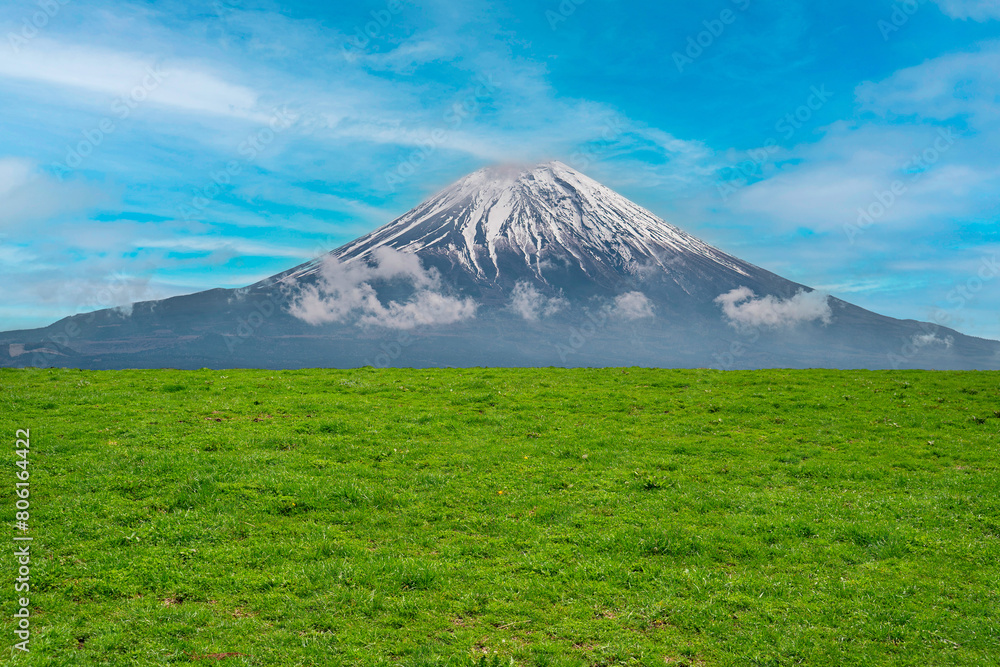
[0, 369, 1000, 667]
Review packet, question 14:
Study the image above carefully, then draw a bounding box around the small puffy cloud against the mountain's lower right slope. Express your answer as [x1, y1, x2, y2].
[715, 287, 833, 329]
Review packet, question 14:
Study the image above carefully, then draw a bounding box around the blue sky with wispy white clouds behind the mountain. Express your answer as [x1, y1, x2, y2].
[0, 0, 1000, 339]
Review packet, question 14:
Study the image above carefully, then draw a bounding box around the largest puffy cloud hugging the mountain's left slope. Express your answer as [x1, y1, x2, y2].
[289, 248, 477, 329]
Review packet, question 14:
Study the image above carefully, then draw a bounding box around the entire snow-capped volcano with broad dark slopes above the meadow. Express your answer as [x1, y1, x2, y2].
[0, 162, 1000, 369]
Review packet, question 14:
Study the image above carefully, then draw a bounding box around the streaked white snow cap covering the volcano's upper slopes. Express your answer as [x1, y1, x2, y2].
[286, 162, 752, 283]
